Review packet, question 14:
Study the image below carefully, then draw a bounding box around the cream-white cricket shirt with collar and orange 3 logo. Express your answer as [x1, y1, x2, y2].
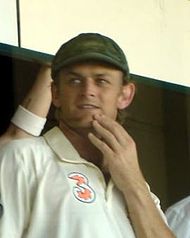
[0, 127, 165, 238]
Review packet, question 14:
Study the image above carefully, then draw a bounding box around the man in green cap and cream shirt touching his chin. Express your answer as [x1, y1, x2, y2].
[0, 33, 174, 238]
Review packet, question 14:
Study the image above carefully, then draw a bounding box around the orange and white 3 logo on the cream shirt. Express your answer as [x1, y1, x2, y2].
[68, 172, 95, 203]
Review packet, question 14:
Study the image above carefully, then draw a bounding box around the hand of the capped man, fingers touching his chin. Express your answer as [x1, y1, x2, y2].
[89, 115, 145, 194]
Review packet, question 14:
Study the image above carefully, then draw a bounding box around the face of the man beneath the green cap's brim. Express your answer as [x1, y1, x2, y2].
[53, 63, 126, 129]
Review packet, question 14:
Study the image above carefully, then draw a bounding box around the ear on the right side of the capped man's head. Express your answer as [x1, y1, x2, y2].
[117, 83, 135, 110]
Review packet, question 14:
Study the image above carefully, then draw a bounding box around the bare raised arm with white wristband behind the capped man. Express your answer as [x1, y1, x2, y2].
[0, 64, 52, 147]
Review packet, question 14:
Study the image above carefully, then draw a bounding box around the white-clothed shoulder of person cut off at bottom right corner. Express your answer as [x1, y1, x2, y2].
[166, 196, 190, 238]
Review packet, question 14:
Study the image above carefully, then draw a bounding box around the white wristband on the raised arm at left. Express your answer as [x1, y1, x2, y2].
[11, 105, 47, 136]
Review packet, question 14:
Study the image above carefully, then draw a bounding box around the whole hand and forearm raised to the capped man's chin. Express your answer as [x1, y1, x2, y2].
[89, 115, 175, 238]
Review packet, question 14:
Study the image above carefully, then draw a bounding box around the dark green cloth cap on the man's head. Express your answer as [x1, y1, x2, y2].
[51, 33, 129, 79]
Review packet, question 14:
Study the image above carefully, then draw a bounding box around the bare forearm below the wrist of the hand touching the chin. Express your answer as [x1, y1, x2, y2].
[124, 181, 175, 238]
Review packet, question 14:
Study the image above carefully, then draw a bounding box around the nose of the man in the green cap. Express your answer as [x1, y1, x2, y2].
[81, 79, 97, 97]
